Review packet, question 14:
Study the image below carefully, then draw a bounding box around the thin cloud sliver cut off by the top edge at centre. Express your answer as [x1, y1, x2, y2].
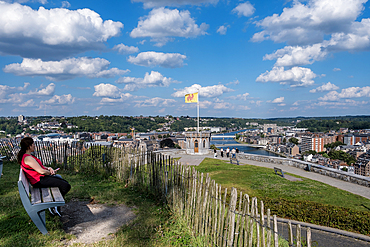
[131, 0, 218, 9]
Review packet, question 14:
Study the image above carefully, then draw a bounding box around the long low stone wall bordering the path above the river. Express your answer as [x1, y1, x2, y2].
[238, 153, 370, 187]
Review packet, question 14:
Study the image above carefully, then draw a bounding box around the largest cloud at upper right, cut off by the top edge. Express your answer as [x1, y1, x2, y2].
[252, 0, 367, 45]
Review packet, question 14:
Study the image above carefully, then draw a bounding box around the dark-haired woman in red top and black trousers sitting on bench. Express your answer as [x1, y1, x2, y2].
[18, 137, 71, 215]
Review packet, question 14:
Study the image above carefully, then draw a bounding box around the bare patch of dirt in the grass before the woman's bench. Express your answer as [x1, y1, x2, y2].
[61, 200, 136, 245]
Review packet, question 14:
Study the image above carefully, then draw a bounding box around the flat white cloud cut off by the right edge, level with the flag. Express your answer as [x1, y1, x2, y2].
[319, 86, 370, 101]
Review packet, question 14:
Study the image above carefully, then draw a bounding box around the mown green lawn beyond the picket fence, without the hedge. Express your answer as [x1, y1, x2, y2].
[196, 158, 370, 212]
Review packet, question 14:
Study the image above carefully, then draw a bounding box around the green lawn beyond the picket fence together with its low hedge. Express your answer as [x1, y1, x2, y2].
[196, 158, 370, 236]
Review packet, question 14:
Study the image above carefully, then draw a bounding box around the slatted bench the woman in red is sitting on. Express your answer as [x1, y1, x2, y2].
[18, 168, 65, 235]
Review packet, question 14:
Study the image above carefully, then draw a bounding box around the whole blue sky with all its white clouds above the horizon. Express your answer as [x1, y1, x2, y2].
[0, 0, 370, 118]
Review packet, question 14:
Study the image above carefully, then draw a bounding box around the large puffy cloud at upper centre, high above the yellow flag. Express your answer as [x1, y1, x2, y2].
[130, 8, 208, 46]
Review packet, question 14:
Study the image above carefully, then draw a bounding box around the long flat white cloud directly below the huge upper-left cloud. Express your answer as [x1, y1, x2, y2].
[3, 57, 129, 81]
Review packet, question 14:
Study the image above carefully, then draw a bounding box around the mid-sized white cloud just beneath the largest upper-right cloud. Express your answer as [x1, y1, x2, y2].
[263, 44, 327, 66]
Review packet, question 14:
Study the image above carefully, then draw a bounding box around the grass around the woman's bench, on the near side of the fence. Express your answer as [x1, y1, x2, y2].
[0, 162, 199, 247]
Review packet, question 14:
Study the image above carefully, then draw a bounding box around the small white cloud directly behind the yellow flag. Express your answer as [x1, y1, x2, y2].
[172, 84, 234, 98]
